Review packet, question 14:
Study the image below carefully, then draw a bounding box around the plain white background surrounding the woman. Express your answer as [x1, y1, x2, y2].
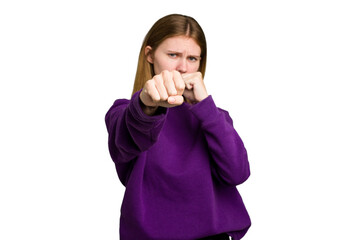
[0, 0, 360, 240]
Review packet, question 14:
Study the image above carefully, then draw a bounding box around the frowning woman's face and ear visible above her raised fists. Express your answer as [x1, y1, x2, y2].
[145, 36, 201, 74]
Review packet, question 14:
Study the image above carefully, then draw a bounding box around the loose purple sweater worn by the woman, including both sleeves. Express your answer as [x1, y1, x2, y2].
[105, 92, 251, 240]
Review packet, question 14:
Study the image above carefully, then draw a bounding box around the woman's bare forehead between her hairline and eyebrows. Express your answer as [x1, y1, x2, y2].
[159, 36, 201, 55]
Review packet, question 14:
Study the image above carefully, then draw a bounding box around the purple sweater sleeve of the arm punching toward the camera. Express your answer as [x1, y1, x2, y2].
[105, 92, 167, 185]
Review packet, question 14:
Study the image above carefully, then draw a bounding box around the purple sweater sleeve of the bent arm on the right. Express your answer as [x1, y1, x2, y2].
[190, 96, 250, 186]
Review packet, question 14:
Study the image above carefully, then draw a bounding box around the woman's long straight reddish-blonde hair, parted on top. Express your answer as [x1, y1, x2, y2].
[132, 14, 206, 95]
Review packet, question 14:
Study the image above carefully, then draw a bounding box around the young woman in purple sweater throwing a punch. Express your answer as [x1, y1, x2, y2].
[105, 14, 250, 240]
